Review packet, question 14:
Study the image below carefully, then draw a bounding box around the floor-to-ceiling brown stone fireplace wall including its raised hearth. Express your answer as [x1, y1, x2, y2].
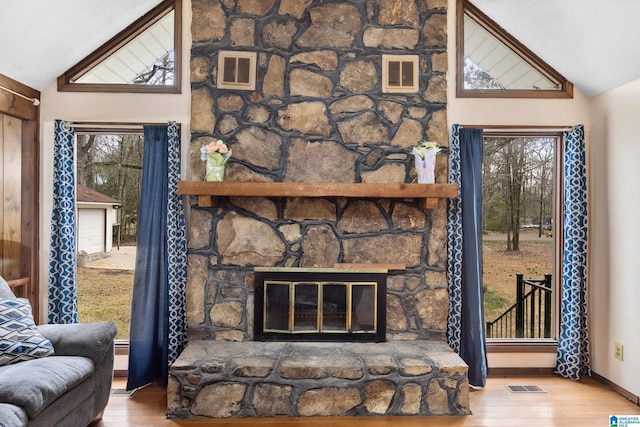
[168, 0, 469, 418]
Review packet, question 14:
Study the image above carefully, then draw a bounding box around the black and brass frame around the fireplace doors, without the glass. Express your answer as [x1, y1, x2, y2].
[254, 267, 388, 342]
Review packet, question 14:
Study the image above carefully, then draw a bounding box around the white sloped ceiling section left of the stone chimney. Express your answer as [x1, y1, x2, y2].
[0, 0, 161, 90]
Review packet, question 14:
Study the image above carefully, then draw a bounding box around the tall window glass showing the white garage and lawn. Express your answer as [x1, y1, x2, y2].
[76, 131, 144, 340]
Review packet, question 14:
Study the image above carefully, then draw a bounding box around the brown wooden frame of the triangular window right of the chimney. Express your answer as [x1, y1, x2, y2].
[456, 0, 573, 98]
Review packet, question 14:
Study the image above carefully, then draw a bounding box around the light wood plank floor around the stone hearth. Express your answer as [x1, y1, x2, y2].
[93, 376, 640, 427]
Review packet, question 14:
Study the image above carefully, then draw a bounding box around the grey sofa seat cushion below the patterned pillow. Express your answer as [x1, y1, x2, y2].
[0, 356, 95, 419]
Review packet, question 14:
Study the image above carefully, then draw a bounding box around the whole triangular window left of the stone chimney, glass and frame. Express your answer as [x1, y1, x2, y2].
[58, 0, 182, 93]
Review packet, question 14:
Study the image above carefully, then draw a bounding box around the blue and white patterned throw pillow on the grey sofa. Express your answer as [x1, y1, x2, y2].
[0, 298, 54, 366]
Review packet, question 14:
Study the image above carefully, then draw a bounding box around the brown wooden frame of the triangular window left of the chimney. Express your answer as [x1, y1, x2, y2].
[58, 0, 182, 93]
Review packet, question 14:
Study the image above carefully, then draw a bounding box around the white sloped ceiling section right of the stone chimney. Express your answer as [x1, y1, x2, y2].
[471, 0, 640, 97]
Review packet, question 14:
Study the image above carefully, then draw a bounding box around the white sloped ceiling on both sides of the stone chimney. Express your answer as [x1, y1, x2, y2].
[0, 0, 640, 96]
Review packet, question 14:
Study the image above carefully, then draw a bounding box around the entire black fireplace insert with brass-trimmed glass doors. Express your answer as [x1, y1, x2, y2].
[254, 267, 387, 342]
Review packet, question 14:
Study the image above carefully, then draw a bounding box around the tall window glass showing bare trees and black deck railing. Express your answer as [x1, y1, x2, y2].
[482, 137, 556, 339]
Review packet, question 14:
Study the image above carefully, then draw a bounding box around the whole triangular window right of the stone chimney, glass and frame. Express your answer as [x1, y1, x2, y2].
[457, 0, 573, 98]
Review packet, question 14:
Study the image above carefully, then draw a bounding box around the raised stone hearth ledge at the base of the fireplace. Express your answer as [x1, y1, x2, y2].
[167, 340, 470, 418]
